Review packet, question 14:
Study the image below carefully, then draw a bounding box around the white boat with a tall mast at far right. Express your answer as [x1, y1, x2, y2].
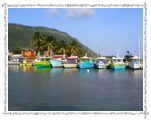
[129, 37, 143, 69]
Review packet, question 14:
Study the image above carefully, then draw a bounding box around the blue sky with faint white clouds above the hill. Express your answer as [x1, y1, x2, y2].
[8, 8, 143, 57]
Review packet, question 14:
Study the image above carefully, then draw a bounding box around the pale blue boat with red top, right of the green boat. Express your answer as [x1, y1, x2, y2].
[49, 55, 66, 68]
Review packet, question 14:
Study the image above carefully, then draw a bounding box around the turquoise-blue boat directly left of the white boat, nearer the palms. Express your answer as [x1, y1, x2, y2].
[78, 53, 95, 68]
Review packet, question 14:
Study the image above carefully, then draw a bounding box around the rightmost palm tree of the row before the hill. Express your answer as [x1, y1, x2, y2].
[68, 40, 81, 55]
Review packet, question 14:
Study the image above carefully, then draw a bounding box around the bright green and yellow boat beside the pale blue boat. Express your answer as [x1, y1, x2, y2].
[33, 57, 52, 67]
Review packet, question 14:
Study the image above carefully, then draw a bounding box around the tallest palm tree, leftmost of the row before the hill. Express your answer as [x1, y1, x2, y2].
[30, 32, 42, 54]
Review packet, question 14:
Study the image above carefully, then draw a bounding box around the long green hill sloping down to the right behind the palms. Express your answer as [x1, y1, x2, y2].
[8, 23, 97, 56]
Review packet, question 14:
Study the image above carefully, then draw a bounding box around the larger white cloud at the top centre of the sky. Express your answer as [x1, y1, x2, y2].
[64, 8, 95, 18]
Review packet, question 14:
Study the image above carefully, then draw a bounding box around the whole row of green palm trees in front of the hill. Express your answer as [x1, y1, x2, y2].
[30, 32, 92, 57]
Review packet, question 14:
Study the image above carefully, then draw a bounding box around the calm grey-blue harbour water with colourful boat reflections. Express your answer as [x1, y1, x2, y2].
[8, 65, 143, 111]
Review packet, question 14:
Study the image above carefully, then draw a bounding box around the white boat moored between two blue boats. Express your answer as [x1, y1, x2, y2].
[96, 50, 107, 68]
